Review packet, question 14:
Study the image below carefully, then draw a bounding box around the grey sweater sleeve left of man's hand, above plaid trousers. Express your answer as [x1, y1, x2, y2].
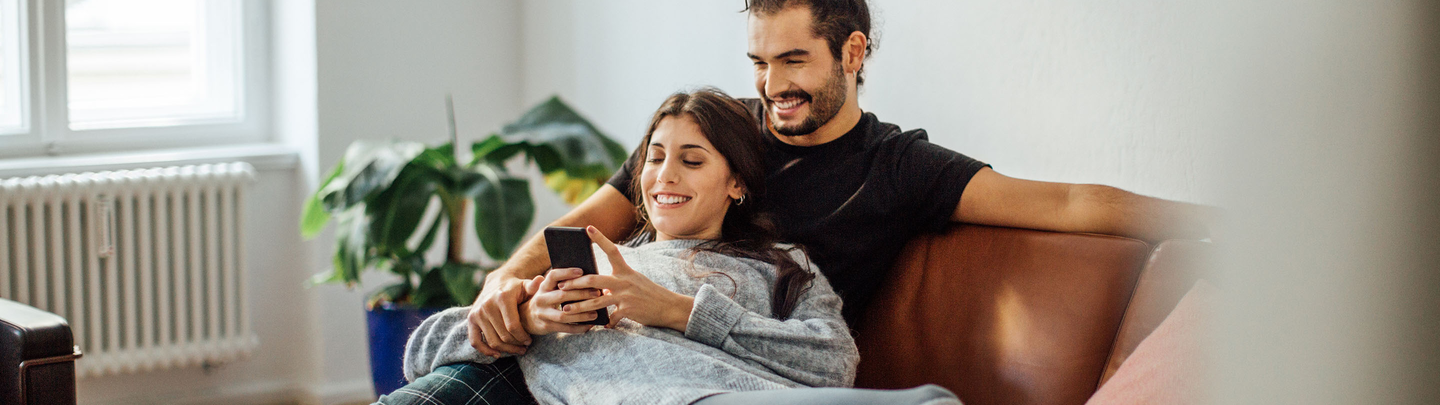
[405, 307, 495, 382]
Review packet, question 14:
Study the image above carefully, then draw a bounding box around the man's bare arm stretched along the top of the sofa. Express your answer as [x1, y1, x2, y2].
[950, 167, 1218, 242]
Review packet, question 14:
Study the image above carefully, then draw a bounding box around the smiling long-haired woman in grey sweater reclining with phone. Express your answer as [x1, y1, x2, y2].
[388, 89, 953, 404]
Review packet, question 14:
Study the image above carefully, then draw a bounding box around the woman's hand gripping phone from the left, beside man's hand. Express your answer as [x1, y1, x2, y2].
[520, 268, 600, 336]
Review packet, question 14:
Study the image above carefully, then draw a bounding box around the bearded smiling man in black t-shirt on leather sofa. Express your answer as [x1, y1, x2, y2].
[377, 0, 1208, 402]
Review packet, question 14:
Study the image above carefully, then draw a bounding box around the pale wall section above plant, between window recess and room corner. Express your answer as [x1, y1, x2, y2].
[317, 0, 521, 167]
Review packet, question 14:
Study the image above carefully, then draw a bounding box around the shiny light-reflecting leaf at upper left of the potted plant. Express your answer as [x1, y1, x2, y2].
[318, 141, 425, 212]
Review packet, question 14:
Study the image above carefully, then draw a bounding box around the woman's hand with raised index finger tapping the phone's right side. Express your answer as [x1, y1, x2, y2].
[559, 226, 696, 331]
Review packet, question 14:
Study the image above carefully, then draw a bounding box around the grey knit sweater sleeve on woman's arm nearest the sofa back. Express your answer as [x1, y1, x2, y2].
[685, 250, 860, 386]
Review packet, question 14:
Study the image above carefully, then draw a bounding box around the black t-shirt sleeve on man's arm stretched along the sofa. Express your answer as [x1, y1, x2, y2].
[896, 133, 989, 232]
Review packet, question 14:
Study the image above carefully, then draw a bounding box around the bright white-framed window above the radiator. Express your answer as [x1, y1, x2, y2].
[0, 0, 265, 157]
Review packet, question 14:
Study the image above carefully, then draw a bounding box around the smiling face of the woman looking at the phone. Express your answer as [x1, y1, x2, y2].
[639, 114, 743, 241]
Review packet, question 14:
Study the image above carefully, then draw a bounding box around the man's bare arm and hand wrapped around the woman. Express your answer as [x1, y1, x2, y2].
[468, 184, 635, 357]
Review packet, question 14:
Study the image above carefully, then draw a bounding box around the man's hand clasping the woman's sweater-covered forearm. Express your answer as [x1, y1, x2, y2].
[467, 274, 530, 357]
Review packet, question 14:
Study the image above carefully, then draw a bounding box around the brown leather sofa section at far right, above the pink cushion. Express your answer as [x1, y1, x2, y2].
[1100, 241, 1214, 385]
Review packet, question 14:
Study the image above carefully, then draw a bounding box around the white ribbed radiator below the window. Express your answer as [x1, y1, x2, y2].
[0, 163, 258, 378]
